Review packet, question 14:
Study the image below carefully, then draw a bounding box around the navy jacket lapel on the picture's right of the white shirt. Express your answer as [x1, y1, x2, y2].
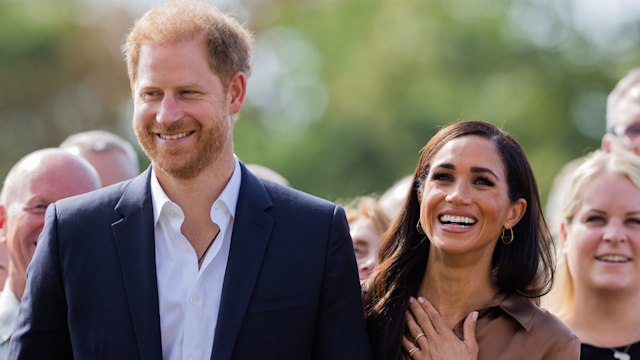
[212, 164, 273, 359]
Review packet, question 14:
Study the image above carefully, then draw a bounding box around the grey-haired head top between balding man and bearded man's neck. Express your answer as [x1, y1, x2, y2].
[59, 130, 140, 186]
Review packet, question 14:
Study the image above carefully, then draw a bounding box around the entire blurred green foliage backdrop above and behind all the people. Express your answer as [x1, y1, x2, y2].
[0, 0, 640, 205]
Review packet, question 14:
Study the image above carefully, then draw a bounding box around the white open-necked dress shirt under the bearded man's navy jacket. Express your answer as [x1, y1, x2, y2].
[151, 157, 241, 360]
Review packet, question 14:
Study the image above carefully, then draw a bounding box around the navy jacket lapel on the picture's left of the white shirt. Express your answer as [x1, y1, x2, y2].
[111, 169, 162, 359]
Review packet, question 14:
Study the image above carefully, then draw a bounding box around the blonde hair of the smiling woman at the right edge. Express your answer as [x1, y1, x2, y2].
[543, 150, 640, 320]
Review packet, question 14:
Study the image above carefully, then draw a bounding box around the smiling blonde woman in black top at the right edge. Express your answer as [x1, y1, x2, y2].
[544, 150, 640, 360]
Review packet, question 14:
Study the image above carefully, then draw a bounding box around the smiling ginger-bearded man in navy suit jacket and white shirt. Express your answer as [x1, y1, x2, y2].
[11, 0, 370, 360]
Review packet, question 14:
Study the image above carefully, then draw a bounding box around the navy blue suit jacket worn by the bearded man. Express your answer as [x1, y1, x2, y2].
[10, 165, 370, 360]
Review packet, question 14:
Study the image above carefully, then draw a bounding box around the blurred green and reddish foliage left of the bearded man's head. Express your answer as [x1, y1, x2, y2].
[0, 0, 131, 178]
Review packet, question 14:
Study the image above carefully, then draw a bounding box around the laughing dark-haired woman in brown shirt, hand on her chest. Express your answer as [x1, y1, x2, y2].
[363, 121, 580, 360]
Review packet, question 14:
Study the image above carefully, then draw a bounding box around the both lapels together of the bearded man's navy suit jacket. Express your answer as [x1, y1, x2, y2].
[112, 162, 274, 359]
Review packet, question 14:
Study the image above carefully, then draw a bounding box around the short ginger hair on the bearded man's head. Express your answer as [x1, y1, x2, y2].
[123, 0, 253, 88]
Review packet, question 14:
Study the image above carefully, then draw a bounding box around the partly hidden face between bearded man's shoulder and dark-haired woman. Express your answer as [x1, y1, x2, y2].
[345, 196, 389, 281]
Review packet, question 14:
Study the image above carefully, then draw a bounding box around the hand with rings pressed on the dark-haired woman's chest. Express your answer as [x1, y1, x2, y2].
[402, 297, 478, 360]
